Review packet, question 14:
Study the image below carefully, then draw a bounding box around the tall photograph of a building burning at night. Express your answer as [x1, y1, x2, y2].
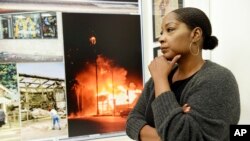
[62, 13, 143, 137]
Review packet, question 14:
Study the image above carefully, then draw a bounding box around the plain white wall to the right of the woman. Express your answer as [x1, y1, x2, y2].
[210, 0, 250, 124]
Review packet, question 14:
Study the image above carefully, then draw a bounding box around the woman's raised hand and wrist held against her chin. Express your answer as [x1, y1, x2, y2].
[148, 55, 181, 97]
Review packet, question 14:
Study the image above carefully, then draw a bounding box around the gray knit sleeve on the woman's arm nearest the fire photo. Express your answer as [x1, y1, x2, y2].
[126, 80, 152, 141]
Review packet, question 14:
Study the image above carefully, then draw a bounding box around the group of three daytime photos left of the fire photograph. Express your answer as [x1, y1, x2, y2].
[0, 10, 68, 141]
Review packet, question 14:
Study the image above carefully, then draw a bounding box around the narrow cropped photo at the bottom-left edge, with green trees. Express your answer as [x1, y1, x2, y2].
[0, 64, 21, 141]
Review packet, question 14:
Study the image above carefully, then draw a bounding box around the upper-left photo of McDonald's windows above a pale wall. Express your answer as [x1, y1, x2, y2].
[0, 10, 63, 63]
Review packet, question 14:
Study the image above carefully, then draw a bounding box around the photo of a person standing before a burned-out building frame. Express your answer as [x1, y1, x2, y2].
[17, 63, 68, 140]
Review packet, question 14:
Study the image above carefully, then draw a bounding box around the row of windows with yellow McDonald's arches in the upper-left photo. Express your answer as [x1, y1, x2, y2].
[0, 11, 57, 39]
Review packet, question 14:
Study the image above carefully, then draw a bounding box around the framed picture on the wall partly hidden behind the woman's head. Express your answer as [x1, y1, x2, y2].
[152, 0, 183, 42]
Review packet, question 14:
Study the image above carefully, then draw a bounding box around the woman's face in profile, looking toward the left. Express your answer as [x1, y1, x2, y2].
[159, 13, 192, 60]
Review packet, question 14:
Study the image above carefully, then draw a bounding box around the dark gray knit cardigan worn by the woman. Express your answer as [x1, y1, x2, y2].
[126, 61, 240, 141]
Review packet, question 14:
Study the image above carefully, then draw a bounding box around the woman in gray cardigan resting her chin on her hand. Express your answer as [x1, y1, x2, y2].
[126, 8, 240, 141]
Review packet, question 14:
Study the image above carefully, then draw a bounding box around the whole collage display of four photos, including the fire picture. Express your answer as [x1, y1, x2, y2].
[0, 0, 143, 141]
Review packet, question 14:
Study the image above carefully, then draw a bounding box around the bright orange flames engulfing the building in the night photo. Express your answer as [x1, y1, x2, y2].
[68, 55, 142, 119]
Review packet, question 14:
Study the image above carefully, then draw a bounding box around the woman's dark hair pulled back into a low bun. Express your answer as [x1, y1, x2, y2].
[172, 7, 218, 50]
